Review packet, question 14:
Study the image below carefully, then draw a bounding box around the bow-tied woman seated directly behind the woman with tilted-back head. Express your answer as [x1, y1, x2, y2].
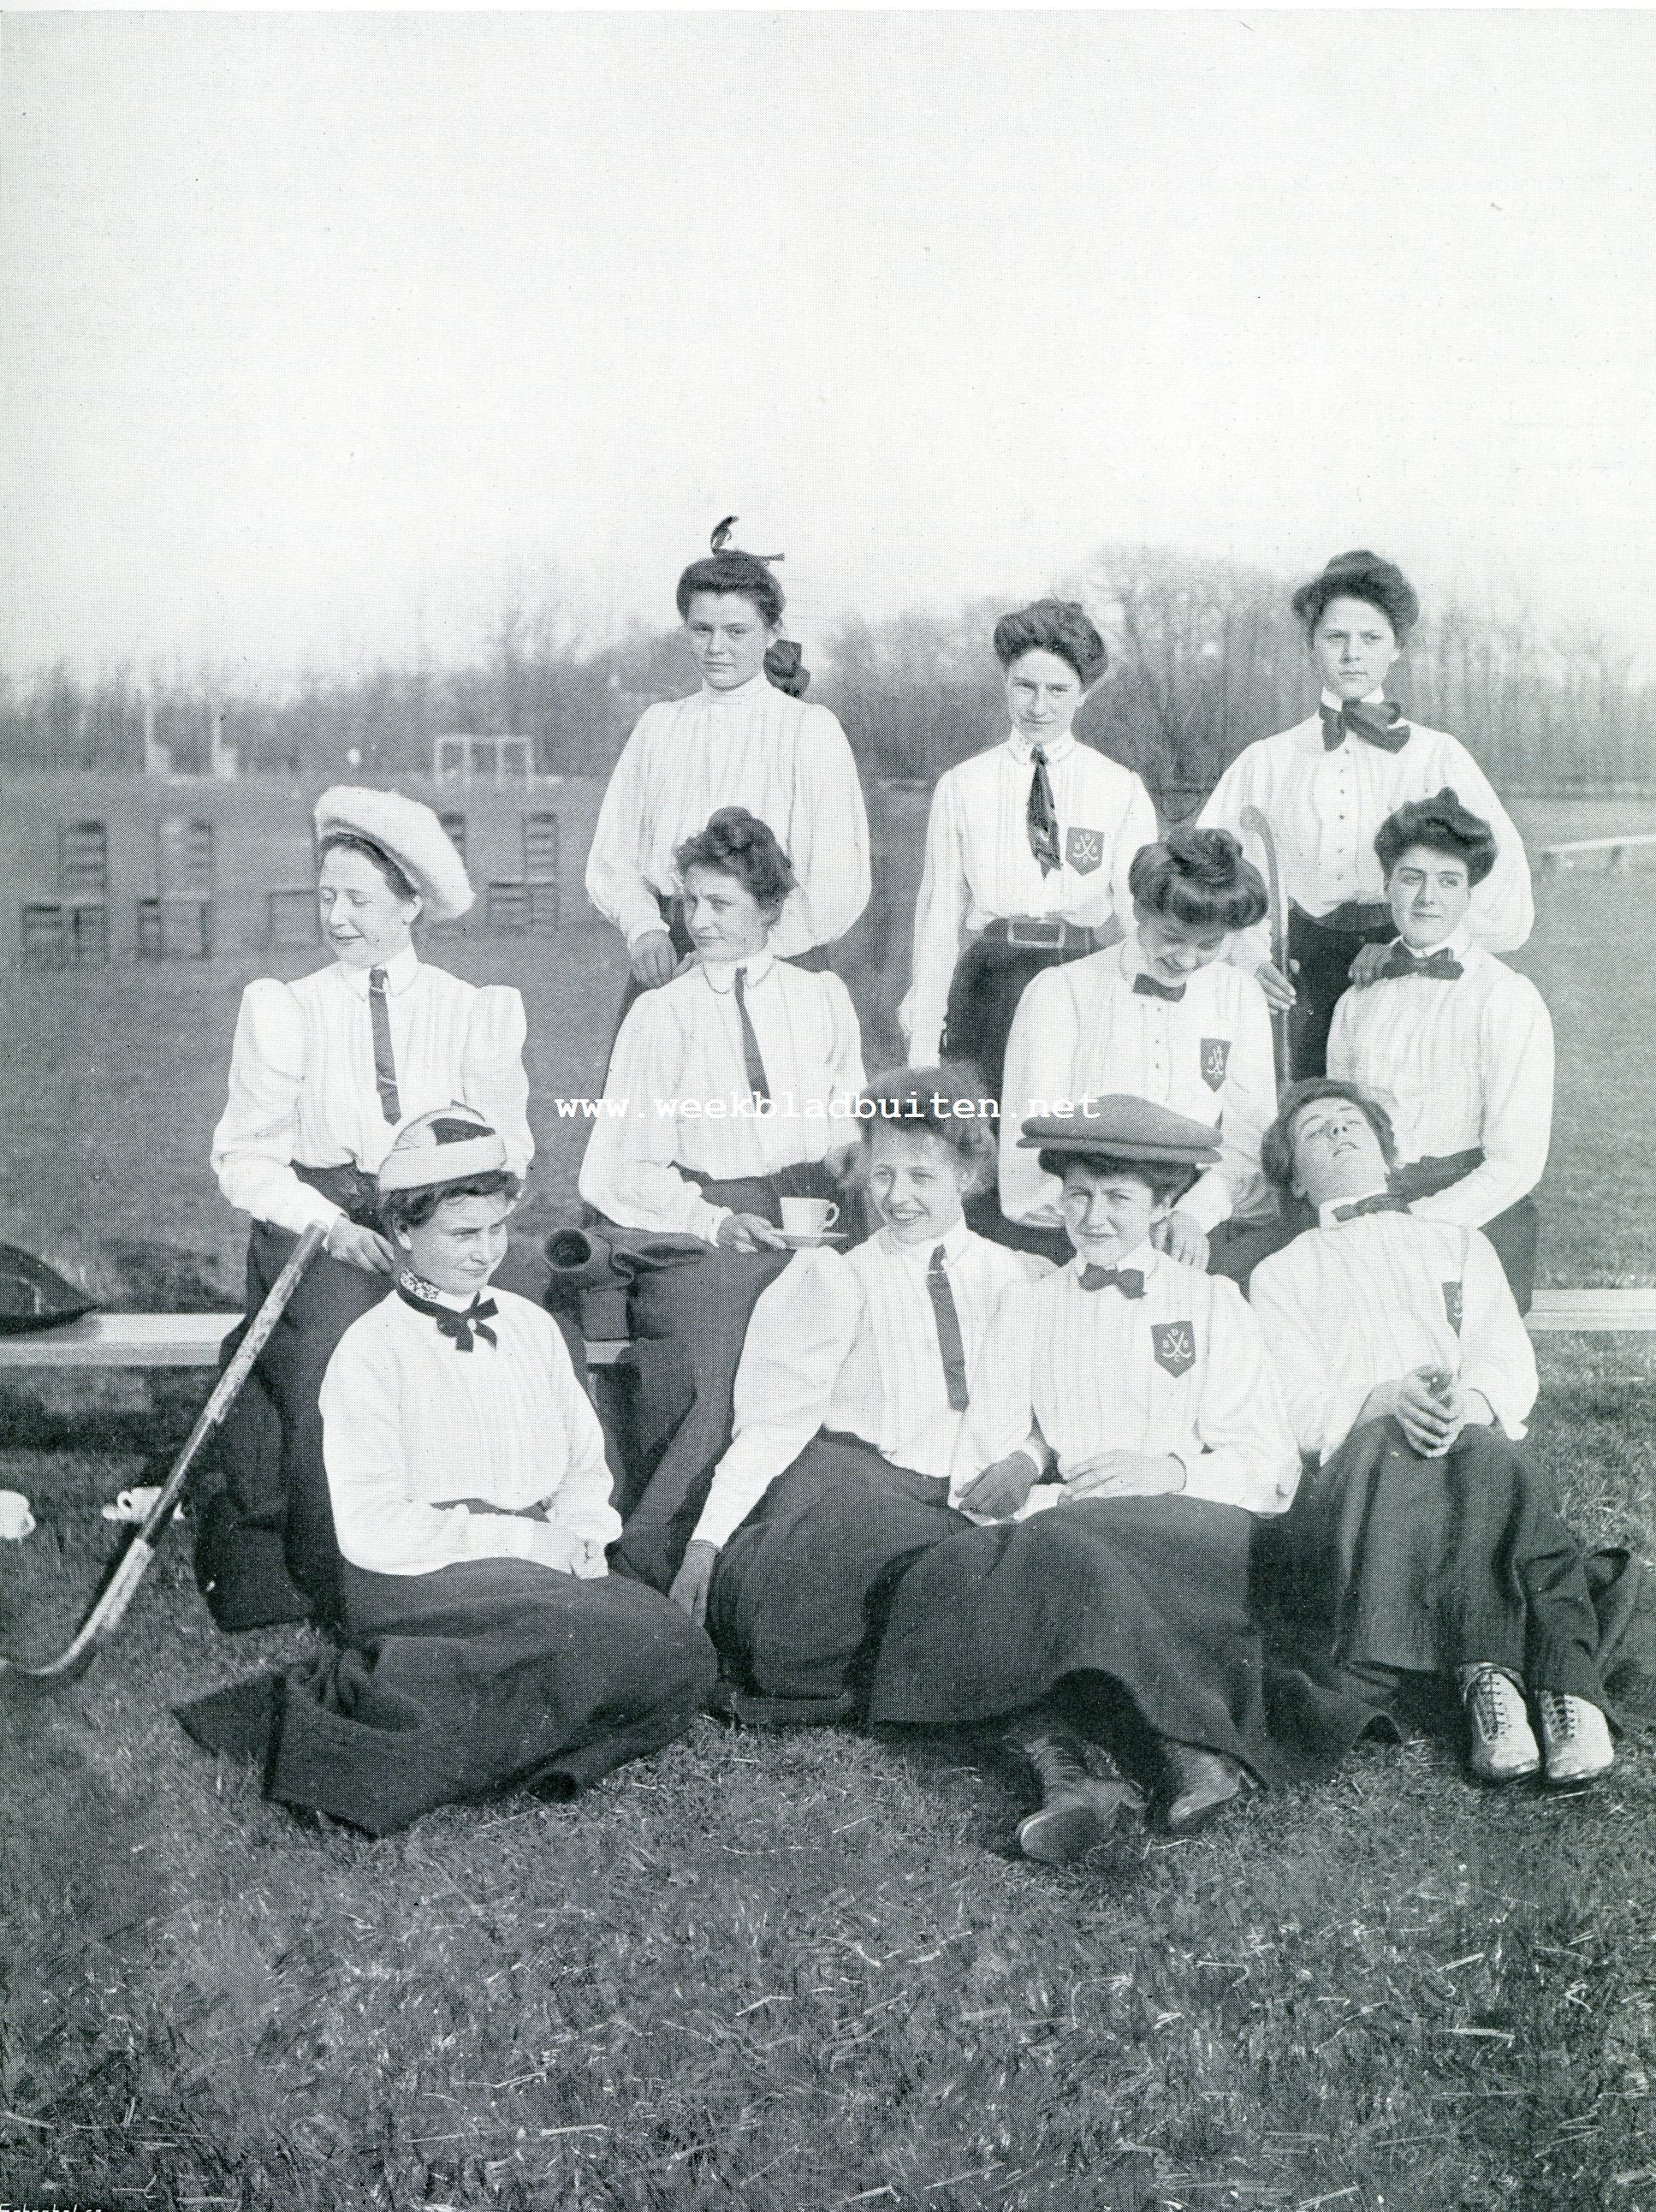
[1329, 788, 1552, 1314]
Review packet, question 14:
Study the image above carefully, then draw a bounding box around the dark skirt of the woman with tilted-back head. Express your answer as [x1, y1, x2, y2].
[1261, 1420, 1606, 1705]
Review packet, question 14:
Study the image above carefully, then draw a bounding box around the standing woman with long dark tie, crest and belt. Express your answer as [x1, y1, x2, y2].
[898, 599, 1156, 1176]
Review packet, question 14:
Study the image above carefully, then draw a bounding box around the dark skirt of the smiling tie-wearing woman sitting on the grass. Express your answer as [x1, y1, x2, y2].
[708, 1431, 970, 1704]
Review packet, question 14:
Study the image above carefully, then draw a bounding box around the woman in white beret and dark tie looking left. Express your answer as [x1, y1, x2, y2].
[197, 785, 535, 1628]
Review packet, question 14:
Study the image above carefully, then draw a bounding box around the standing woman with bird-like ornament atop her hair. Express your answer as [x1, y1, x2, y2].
[586, 518, 869, 1013]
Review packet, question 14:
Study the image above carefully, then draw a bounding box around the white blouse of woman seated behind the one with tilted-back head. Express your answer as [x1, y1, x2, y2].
[1329, 929, 1552, 1228]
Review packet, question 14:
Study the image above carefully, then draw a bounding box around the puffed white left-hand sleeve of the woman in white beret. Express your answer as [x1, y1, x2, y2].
[212, 978, 341, 1236]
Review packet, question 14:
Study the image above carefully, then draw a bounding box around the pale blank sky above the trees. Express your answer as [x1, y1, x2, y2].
[0, 11, 1656, 681]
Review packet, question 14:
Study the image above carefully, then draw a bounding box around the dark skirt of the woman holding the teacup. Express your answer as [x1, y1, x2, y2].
[610, 1162, 836, 1591]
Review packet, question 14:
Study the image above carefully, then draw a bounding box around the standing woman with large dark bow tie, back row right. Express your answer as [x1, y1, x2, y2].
[1201, 549, 1534, 1075]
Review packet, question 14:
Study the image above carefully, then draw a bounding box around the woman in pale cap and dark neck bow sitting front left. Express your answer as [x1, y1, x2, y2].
[179, 1106, 714, 1834]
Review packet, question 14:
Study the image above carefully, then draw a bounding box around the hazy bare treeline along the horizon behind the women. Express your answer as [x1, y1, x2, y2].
[0, 546, 1656, 812]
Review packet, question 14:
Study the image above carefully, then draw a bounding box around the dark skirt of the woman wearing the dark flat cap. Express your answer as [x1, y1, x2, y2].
[869, 1495, 1280, 1779]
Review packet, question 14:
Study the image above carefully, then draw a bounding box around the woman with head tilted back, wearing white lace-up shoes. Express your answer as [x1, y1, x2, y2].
[1251, 1079, 1614, 1787]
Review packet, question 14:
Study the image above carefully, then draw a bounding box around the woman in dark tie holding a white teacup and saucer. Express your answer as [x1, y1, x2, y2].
[579, 807, 863, 1591]
